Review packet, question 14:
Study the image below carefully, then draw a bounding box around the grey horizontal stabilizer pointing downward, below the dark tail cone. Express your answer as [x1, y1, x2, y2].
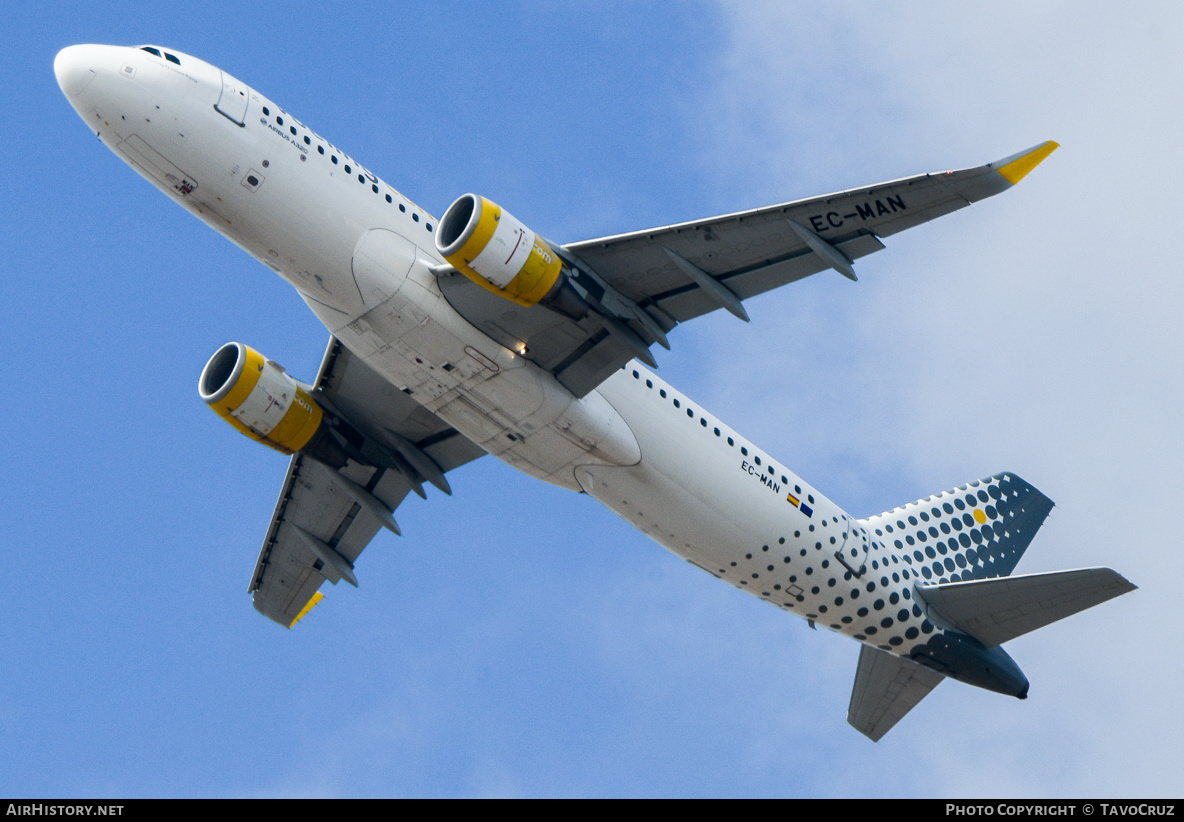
[847, 646, 945, 741]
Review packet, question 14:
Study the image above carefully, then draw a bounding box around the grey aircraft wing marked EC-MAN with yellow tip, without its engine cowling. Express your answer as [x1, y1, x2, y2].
[438, 141, 1057, 397]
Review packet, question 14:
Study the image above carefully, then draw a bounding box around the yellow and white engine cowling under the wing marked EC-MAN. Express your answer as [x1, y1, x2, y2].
[436, 194, 562, 308]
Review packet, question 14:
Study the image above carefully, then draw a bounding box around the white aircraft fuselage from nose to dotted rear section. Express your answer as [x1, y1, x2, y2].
[56, 46, 940, 653]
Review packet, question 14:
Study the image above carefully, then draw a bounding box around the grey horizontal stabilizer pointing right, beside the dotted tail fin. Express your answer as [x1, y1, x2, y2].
[914, 569, 1137, 649]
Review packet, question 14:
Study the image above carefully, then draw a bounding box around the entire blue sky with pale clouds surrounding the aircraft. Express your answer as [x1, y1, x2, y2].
[0, 1, 1184, 796]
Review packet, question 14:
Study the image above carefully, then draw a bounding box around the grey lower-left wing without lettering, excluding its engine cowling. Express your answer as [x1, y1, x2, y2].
[249, 338, 484, 628]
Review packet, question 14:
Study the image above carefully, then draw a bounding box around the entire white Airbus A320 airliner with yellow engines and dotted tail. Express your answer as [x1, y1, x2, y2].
[53, 45, 1134, 740]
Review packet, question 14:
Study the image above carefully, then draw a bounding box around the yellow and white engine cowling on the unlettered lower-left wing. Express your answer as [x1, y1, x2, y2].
[198, 342, 324, 454]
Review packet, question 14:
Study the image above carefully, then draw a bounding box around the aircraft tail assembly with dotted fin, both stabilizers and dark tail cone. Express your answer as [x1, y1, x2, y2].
[844, 473, 1134, 740]
